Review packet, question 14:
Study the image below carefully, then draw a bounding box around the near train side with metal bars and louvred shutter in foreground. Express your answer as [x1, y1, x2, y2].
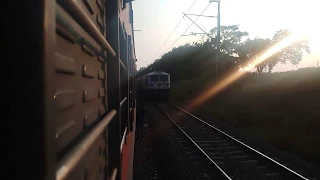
[8, 0, 137, 180]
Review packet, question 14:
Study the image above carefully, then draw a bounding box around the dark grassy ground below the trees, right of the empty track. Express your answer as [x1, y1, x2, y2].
[171, 68, 320, 167]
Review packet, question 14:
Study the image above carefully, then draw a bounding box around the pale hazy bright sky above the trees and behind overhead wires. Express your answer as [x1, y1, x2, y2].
[133, 0, 320, 71]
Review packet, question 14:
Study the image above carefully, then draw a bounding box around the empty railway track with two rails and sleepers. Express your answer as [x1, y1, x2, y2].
[157, 103, 316, 180]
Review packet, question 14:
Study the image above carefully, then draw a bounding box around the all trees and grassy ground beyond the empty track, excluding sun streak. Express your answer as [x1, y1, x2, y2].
[138, 26, 320, 166]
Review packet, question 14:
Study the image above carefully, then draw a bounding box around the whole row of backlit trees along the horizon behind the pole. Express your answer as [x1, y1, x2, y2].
[138, 25, 310, 81]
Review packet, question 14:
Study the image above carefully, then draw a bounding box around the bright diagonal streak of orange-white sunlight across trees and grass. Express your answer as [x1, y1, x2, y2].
[186, 33, 305, 111]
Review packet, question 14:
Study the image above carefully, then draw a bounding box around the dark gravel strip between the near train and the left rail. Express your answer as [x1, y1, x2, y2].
[133, 103, 220, 180]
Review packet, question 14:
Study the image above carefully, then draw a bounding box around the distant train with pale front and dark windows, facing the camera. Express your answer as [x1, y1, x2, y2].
[137, 71, 171, 100]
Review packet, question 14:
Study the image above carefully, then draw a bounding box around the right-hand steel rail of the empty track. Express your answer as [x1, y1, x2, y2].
[168, 102, 308, 180]
